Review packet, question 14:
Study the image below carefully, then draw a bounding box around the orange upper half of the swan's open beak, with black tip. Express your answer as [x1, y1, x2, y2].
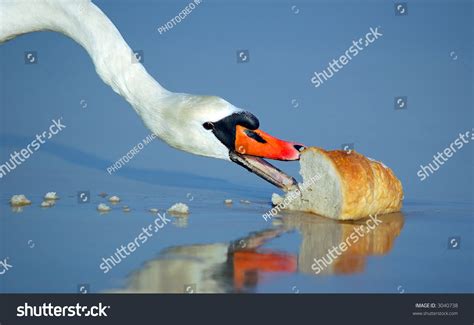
[235, 125, 304, 160]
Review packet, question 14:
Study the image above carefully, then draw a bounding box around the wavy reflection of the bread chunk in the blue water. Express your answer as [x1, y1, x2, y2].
[283, 212, 404, 274]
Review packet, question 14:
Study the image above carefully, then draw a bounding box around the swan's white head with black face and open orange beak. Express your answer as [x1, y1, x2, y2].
[153, 94, 304, 189]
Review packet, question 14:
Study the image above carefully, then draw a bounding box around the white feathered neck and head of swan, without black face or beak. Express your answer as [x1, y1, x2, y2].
[0, 0, 239, 159]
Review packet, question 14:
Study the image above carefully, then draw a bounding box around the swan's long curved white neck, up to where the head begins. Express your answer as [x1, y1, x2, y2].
[0, 0, 169, 118]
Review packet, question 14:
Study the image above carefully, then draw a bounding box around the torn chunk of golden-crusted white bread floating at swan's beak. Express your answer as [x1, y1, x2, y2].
[272, 147, 403, 220]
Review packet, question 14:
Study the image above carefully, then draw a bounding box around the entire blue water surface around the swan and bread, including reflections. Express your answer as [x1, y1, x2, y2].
[0, 0, 474, 293]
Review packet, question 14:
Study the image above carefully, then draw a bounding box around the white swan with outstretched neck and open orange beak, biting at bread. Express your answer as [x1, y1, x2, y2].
[0, 0, 304, 190]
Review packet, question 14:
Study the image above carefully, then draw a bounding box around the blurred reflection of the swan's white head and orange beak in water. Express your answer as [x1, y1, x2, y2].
[111, 229, 296, 293]
